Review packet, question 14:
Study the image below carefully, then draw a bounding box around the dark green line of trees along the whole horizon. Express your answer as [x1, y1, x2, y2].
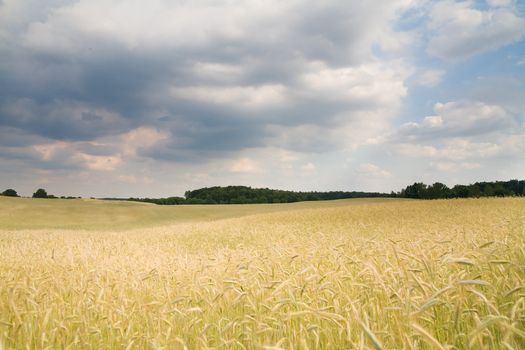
[0, 180, 525, 205]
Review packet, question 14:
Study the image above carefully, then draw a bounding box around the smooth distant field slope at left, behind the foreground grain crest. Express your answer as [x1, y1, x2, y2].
[0, 196, 403, 230]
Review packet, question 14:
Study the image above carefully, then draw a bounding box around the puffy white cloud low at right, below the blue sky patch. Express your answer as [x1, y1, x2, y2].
[389, 101, 525, 171]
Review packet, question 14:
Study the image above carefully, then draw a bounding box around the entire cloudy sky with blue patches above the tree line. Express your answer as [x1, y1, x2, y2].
[0, 0, 525, 197]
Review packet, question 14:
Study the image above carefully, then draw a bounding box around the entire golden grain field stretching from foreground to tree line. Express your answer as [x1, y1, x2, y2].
[0, 198, 525, 350]
